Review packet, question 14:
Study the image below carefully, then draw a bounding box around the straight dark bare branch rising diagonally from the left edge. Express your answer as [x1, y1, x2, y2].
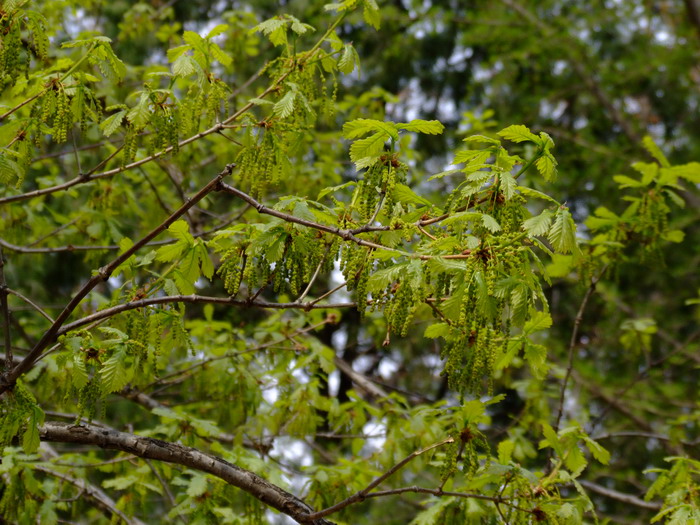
[0, 164, 234, 395]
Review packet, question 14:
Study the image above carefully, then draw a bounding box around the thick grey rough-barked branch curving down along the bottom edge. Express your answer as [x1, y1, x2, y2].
[40, 422, 331, 525]
